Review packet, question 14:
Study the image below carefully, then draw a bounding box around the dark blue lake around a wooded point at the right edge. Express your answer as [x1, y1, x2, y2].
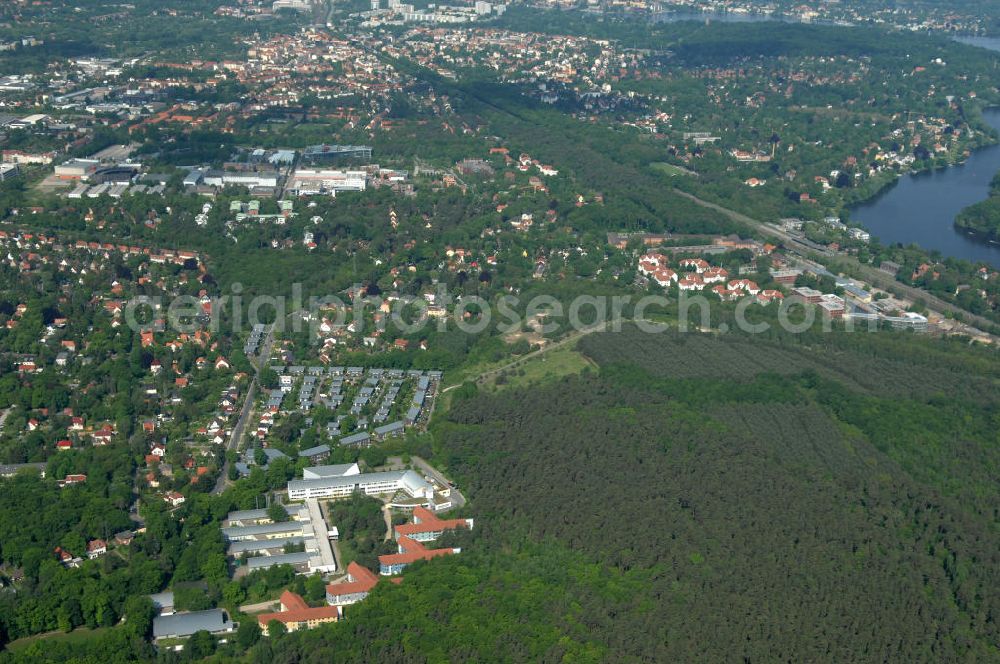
[851, 109, 1000, 267]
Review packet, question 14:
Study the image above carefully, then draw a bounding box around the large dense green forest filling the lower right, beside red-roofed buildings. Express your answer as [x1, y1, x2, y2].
[244, 331, 1000, 662]
